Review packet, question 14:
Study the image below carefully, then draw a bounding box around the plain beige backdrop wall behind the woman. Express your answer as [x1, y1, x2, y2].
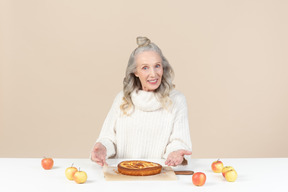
[0, 0, 288, 158]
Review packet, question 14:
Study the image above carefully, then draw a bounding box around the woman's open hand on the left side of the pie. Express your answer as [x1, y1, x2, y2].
[91, 142, 108, 167]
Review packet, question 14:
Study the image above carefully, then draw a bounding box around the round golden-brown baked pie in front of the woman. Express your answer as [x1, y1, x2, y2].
[118, 160, 162, 176]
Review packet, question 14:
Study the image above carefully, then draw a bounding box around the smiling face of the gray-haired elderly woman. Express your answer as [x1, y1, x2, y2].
[135, 51, 163, 91]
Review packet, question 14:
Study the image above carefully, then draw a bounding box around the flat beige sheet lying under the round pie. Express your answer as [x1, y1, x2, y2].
[103, 166, 178, 181]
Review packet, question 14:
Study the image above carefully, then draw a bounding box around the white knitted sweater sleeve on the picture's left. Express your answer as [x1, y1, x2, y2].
[96, 92, 123, 158]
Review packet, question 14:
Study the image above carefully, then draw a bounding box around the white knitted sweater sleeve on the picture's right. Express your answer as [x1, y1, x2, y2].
[164, 94, 192, 159]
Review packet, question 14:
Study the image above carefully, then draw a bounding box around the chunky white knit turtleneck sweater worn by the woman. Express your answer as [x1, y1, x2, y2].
[96, 90, 192, 159]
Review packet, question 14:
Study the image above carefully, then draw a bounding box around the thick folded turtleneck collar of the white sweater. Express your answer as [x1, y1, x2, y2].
[131, 90, 162, 111]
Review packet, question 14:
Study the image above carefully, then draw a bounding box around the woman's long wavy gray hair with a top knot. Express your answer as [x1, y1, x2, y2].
[120, 37, 175, 115]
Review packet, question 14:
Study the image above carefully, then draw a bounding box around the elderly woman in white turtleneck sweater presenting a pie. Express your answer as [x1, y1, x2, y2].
[91, 37, 192, 166]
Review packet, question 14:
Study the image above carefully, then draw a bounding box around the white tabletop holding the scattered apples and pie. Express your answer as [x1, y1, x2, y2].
[0, 158, 288, 192]
